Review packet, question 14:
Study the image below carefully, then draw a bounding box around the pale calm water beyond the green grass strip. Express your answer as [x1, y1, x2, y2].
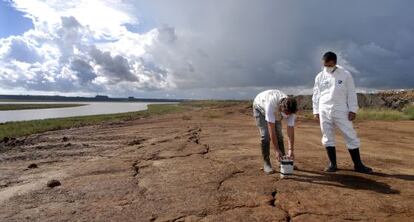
[0, 102, 163, 123]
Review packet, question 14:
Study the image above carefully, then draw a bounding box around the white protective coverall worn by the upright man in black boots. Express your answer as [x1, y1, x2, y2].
[312, 66, 360, 149]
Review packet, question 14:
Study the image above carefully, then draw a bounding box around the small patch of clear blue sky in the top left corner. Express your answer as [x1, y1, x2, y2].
[0, 1, 33, 38]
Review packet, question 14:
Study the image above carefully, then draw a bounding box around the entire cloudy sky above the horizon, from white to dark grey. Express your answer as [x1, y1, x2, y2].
[0, 0, 414, 99]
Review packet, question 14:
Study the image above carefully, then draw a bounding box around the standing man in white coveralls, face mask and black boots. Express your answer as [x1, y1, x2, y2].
[312, 52, 372, 173]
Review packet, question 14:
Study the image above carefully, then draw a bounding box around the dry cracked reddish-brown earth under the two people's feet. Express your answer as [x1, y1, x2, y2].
[0, 104, 414, 221]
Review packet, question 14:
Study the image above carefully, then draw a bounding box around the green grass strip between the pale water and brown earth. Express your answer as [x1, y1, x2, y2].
[0, 104, 185, 140]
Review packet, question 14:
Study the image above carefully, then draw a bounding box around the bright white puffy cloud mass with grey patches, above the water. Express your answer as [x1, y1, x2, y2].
[0, 0, 172, 93]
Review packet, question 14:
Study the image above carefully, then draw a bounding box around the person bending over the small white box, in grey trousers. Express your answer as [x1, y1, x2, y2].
[253, 90, 297, 174]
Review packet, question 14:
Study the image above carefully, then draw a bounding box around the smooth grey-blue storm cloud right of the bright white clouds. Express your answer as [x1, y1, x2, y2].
[136, 0, 414, 88]
